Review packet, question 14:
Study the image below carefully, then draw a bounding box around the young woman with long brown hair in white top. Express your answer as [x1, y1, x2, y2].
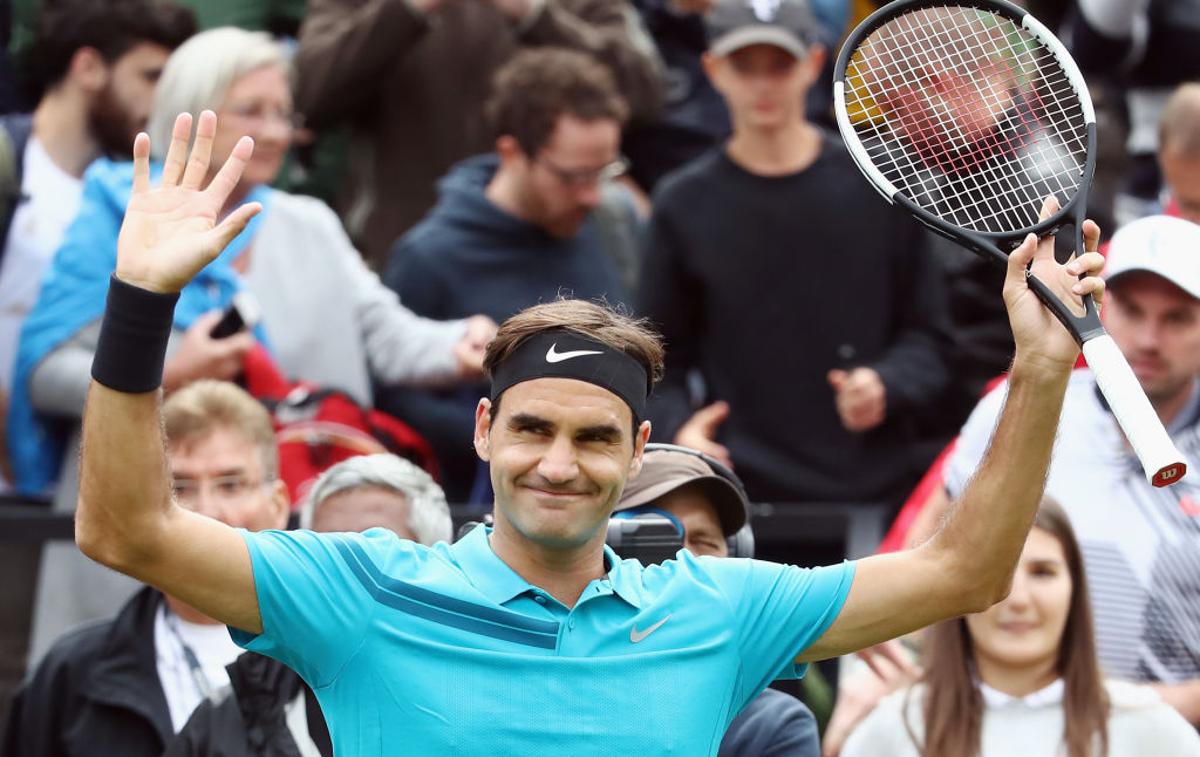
[841, 501, 1200, 757]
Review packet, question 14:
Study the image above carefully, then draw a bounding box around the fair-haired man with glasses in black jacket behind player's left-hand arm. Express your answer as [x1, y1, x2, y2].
[0, 379, 289, 757]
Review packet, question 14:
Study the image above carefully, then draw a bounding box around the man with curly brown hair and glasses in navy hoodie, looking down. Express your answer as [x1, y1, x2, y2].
[379, 48, 638, 501]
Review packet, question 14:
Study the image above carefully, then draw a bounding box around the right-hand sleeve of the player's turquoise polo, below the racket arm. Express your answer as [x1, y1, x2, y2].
[713, 559, 854, 703]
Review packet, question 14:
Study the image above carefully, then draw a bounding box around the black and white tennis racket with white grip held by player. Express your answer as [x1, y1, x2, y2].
[834, 0, 1187, 486]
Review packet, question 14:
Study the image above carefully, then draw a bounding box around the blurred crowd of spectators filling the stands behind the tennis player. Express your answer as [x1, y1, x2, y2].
[0, 0, 1200, 757]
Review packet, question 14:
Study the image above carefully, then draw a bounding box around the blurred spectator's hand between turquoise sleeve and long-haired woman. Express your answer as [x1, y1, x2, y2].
[821, 639, 920, 757]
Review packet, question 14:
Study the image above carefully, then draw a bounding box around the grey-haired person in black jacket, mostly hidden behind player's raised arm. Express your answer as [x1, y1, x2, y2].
[164, 455, 451, 757]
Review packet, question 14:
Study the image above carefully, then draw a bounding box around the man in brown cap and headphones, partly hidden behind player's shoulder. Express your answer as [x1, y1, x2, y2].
[617, 445, 821, 757]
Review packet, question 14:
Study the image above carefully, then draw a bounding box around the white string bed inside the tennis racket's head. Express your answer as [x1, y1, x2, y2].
[845, 7, 1087, 232]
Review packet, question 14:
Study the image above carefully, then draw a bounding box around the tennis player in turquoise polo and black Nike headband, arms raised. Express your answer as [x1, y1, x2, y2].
[76, 112, 1104, 756]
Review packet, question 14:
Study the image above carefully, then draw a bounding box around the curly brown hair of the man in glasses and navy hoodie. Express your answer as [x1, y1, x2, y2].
[486, 47, 629, 156]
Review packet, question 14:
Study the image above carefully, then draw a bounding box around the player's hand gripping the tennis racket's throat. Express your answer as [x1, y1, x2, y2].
[1004, 196, 1104, 370]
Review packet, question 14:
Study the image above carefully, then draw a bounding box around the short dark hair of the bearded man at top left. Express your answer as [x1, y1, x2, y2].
[22, 0, 196, 103]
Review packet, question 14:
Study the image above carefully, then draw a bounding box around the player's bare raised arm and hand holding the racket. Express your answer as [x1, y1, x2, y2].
[798, 207, 1104, 662]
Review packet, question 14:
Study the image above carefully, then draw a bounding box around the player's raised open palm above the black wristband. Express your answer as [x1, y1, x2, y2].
[116, 110, 262, 292]
